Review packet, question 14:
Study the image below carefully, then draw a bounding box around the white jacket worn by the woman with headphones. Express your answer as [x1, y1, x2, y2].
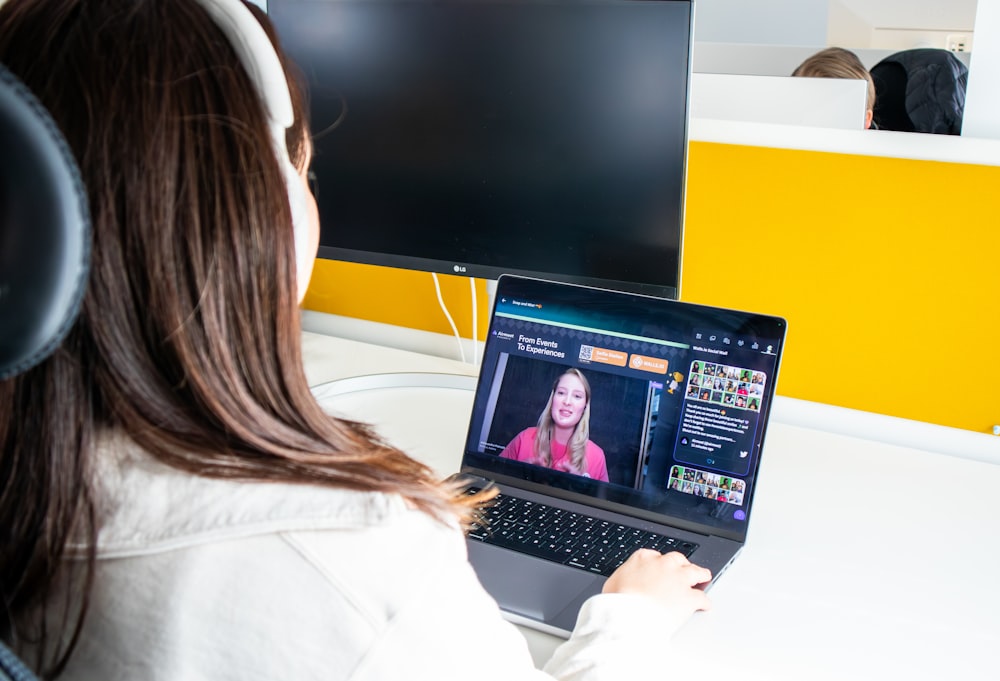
[54, 443, 692, 681]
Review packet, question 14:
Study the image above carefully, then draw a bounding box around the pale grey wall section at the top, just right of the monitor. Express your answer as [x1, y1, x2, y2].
[694, 0, 828, 45]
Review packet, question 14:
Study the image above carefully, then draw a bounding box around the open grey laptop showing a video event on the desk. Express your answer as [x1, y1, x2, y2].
[460, 275, 787, 636]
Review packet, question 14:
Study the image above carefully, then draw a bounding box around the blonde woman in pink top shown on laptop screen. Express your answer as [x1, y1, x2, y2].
[500, 369, 608, 482]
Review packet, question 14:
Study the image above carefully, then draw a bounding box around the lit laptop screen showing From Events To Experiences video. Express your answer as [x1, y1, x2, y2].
[463, 276, 786, 539]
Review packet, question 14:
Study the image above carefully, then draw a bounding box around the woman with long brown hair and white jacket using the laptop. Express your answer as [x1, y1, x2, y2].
[0, 0, 710, 679]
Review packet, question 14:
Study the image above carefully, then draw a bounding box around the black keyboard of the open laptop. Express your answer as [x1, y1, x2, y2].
[468, 490, 698, 577]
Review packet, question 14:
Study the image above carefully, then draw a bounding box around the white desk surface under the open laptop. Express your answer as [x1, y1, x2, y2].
[304, 333, 1000, 681]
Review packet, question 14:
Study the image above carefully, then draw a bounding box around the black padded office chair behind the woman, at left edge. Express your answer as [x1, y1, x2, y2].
[0, 65, 90, 681]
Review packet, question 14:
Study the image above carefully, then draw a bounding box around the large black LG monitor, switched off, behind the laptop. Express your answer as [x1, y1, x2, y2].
[267, 0, 693, 297]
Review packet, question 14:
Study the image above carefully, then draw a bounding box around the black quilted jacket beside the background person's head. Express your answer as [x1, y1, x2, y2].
[871, 48, 969, 135]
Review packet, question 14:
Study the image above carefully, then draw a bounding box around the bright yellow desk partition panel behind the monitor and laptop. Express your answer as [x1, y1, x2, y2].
[305, 142, 1000, 432]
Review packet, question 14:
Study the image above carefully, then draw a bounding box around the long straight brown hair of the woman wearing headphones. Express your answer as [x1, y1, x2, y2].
[0, 0, 484, 675]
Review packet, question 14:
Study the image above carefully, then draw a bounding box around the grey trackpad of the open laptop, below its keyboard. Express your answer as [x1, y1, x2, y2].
[468, 540, 604, 628]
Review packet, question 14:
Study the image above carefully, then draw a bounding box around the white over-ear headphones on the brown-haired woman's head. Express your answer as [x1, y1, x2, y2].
[188, 0, 316, 300]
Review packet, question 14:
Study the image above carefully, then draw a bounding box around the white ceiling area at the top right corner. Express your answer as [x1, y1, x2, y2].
[833, 0, 976, 31]
